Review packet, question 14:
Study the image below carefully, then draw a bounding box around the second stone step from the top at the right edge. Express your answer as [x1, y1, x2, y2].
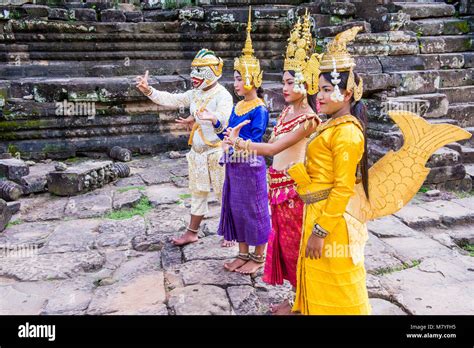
[404, 17, 469, 36]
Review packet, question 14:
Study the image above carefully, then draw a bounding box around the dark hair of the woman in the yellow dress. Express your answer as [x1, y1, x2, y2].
[321, 71, 369, 199]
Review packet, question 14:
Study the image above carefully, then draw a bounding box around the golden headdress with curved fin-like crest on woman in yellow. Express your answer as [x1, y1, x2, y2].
[319, 27, 364, 101]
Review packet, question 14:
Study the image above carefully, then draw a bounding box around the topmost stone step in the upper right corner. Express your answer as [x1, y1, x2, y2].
[386, 2, 456, 19]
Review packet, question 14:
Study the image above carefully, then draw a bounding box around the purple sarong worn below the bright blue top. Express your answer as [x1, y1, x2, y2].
[217, 155, 271, 246]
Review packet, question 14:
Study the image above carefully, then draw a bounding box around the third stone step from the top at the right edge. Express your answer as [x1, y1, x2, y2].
[418, 35, 474, 53]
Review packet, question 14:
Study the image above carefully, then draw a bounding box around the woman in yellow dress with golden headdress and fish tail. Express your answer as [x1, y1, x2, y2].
[226, 27, 471, 314]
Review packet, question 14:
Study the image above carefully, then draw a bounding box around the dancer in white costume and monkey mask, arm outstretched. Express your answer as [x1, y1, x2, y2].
[137, 49, 233, 246]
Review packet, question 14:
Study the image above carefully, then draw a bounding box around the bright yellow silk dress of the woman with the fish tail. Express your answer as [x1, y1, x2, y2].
[288, 115, 371, 315]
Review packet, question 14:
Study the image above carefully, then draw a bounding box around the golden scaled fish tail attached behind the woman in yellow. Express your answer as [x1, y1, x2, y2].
[346, 111, 471, 222]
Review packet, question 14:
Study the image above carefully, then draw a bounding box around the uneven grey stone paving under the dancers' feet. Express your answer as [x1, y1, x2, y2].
[0, 154, 474, 315]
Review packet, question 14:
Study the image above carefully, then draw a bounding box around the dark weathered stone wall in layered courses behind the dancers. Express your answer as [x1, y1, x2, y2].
[0, 0, 474, 190]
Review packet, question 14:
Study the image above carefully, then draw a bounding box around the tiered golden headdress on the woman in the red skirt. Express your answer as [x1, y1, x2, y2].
[283, 9, 320, 95]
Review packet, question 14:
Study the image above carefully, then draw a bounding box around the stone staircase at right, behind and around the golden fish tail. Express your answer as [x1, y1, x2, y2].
[382, 1, 474, 191]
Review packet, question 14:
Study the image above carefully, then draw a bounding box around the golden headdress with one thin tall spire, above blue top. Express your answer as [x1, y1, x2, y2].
[234, 6, 263, 90]
